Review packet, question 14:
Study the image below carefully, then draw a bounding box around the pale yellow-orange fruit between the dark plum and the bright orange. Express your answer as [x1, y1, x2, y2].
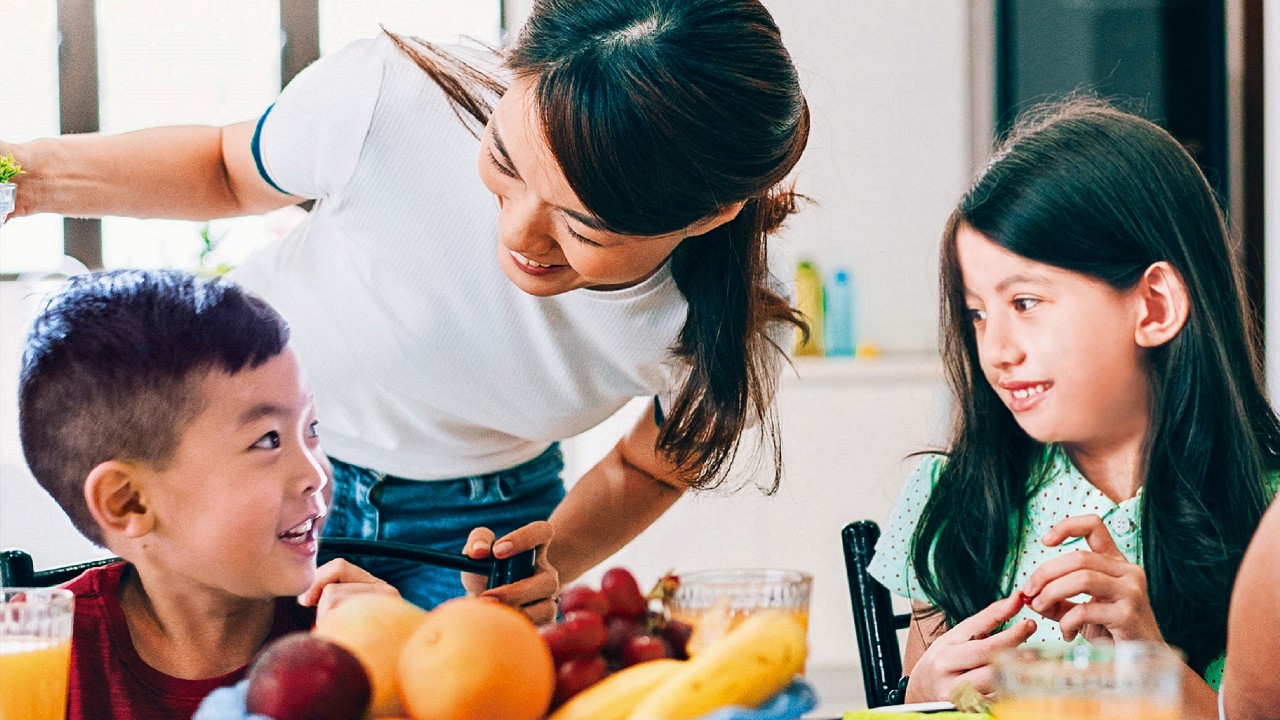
[314, 593, 428, 717]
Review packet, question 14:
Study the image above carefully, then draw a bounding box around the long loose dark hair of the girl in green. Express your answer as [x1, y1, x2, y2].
[913, 100, 1280, 671]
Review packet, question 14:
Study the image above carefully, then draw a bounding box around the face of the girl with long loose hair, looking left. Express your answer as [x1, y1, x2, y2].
[955, 224, 1148, 451]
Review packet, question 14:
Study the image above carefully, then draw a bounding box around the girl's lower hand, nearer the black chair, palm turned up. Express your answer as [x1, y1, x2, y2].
[905, 594, 1036, 702]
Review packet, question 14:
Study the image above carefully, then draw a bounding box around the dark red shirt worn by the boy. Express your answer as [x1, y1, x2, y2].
[63, 562, 315, 720]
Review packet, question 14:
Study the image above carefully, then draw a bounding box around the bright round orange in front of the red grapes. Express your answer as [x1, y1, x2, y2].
[399, 597, 556, 720]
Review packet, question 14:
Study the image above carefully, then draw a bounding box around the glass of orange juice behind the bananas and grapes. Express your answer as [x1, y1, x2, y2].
[667, 568, 813, 655]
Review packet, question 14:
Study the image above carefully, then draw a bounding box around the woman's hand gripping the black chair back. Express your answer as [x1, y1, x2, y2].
[462, 520, 559, 625]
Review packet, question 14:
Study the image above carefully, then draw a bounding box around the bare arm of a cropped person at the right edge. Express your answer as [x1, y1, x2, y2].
[1222, 502, 1280, 720]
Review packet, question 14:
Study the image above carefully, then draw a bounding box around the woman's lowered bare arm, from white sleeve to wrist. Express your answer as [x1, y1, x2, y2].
[548, 404, 686, 584]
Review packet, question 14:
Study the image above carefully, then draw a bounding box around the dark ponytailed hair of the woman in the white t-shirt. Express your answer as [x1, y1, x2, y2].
[386, 0, 809, 489]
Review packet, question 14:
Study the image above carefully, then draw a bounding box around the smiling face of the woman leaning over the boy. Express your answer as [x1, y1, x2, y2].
[479, 78, 741, 296]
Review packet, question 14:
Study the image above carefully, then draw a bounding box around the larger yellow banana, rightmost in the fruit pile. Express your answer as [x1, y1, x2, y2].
[628, 610, 808, 720]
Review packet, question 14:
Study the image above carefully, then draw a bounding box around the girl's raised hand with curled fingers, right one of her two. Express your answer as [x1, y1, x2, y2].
[1023, 515, 1165, 643]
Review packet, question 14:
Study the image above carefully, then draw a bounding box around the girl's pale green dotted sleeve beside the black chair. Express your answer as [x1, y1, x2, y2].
[869, 455, 943, 605]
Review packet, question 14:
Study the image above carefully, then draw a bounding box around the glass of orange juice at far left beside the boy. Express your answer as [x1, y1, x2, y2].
[0, 588, 76, 720]
